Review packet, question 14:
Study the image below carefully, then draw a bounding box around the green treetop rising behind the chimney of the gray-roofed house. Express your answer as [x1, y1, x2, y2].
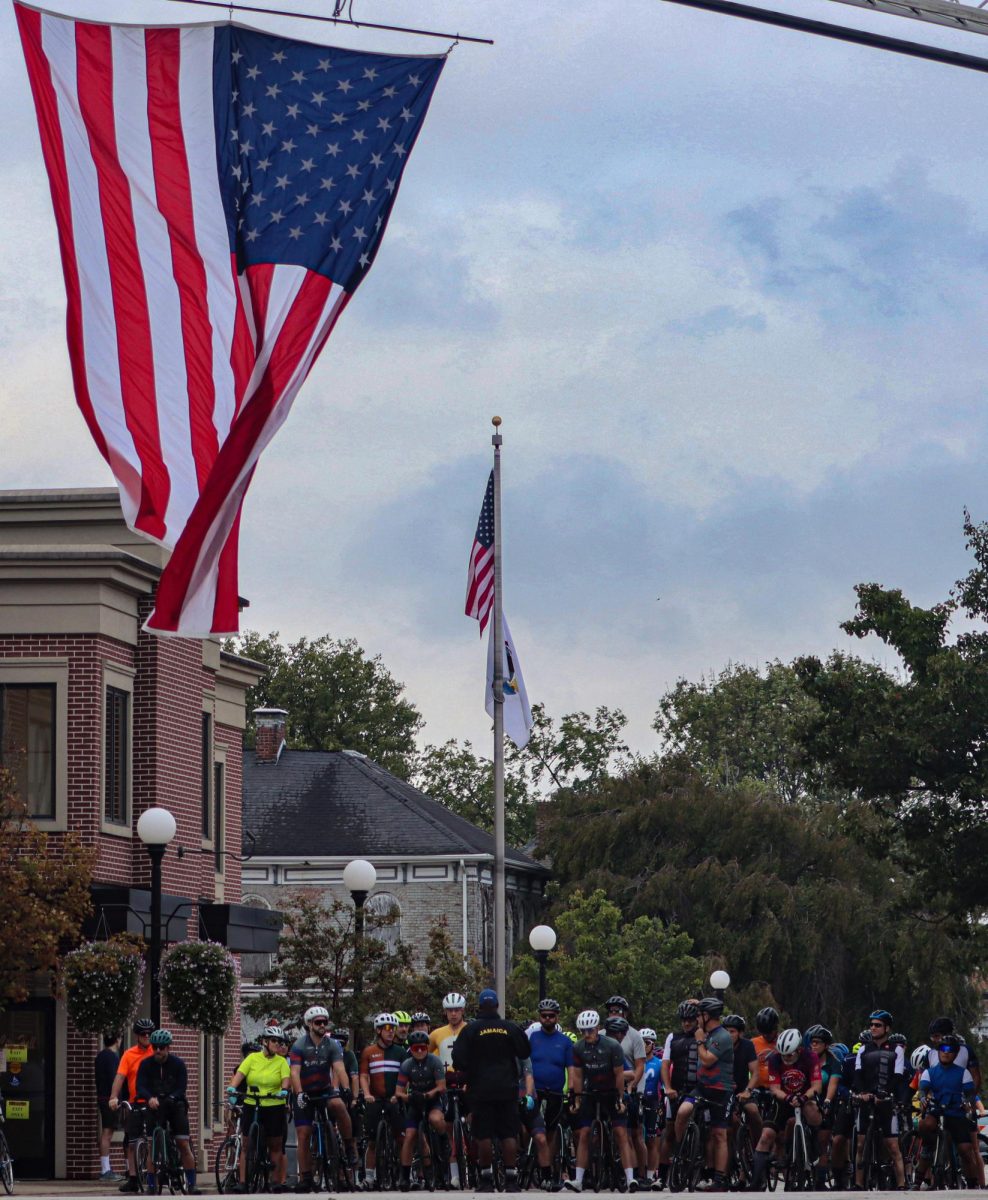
[227, 631, 424, 779]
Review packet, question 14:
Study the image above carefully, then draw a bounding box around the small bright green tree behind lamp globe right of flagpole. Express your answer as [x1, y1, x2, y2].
[508, 888, 702, 1028]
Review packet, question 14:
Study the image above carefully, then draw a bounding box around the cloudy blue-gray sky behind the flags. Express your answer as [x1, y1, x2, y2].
[0, 0, 988, 750]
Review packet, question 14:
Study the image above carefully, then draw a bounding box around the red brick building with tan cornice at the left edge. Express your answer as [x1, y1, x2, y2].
[0, 488, 274, 1178]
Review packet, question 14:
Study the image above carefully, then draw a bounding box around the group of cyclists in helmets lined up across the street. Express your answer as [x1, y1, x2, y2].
[100, 989, 984, 1194]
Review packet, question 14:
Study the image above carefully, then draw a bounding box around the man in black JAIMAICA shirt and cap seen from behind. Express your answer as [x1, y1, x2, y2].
[453, 988, 532, 1192]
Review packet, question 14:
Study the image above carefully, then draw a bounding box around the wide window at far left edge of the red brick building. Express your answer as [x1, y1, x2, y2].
[0, 683, 55, 818]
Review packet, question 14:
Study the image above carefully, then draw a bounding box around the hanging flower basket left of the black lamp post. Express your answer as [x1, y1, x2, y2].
[61, 936, 144, 1033]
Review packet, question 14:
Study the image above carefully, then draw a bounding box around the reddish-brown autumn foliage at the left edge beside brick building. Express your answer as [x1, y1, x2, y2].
[0, 768, 96, 1012]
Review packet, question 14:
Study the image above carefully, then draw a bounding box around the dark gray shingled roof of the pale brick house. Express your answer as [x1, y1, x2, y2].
[244, 750, 550, 875]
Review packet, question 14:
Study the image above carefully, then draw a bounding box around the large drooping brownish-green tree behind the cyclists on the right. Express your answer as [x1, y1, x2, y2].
[545, 758, 984, 1032]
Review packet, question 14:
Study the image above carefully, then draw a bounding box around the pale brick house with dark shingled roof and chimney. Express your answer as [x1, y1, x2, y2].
[242, 708, 551, 1027]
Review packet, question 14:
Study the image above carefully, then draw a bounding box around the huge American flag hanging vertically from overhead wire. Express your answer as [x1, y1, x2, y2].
[14, 4, 444, 636]
